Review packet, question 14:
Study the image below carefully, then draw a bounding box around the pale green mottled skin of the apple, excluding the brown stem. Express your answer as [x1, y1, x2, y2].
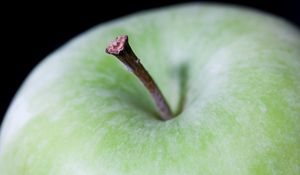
[0, 3, 300, 175]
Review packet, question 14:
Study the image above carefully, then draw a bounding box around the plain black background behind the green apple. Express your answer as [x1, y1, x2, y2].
[0, 0, 300, 122]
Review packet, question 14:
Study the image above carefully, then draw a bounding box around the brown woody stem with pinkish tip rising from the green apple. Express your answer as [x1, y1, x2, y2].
[105, 35, 173, 120]
